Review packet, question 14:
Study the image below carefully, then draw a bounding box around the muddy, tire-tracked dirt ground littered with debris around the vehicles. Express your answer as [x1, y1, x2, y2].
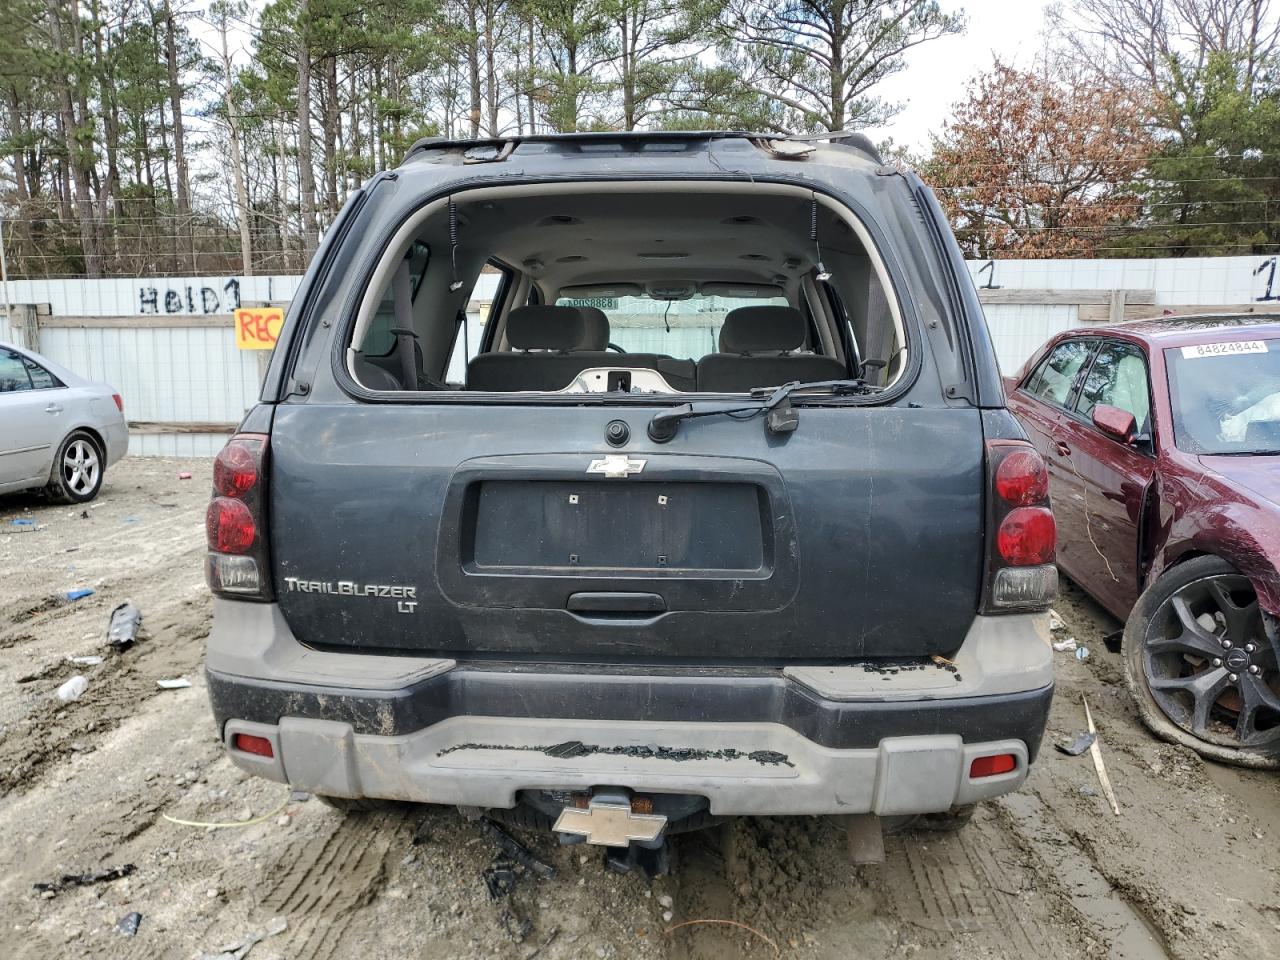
[0, 460, 1280, 960]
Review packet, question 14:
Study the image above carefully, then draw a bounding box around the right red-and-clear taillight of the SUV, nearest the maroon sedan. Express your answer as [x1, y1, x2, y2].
[983, 440, 1057, 613]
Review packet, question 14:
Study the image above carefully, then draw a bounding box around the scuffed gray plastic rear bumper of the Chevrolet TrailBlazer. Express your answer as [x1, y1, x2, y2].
[207, 600, 1053, 815]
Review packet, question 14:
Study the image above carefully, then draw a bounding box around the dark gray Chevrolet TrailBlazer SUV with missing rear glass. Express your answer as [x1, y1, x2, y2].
[207, 133, 1056, 865]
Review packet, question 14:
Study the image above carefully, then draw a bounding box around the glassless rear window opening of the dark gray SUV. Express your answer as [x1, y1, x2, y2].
[346, 183, 908, 401]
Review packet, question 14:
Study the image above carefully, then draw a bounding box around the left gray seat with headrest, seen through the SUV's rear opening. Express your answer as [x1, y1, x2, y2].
[467, 305, 609, 392]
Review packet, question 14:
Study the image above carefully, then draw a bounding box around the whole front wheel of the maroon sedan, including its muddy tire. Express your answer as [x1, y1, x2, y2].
[1120, 557, 1280, 769]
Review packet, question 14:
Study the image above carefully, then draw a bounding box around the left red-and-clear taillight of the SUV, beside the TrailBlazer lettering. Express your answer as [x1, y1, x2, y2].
[205, 434, 271, 600]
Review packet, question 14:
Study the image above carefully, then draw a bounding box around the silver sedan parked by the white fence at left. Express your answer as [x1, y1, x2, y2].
[0, 343, 129, 503]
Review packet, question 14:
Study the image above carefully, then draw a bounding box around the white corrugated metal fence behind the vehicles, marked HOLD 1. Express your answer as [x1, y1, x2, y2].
[0, 257, 1280, 456]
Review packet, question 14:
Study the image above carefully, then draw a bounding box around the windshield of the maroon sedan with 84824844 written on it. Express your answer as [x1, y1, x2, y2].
[1165, 339, 1280, 454]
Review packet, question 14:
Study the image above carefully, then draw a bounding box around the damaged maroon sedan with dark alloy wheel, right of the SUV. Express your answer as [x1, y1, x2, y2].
[1006, 316, 1280, 767]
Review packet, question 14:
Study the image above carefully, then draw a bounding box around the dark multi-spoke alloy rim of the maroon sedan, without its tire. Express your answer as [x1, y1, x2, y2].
[1142, 575, 1280, 748]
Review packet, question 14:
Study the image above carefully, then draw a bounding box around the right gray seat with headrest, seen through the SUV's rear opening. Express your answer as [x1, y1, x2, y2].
[698, 306, 849, 393]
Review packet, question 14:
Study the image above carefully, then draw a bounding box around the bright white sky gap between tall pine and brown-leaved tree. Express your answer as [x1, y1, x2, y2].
[868, 0, 1050, 151]
